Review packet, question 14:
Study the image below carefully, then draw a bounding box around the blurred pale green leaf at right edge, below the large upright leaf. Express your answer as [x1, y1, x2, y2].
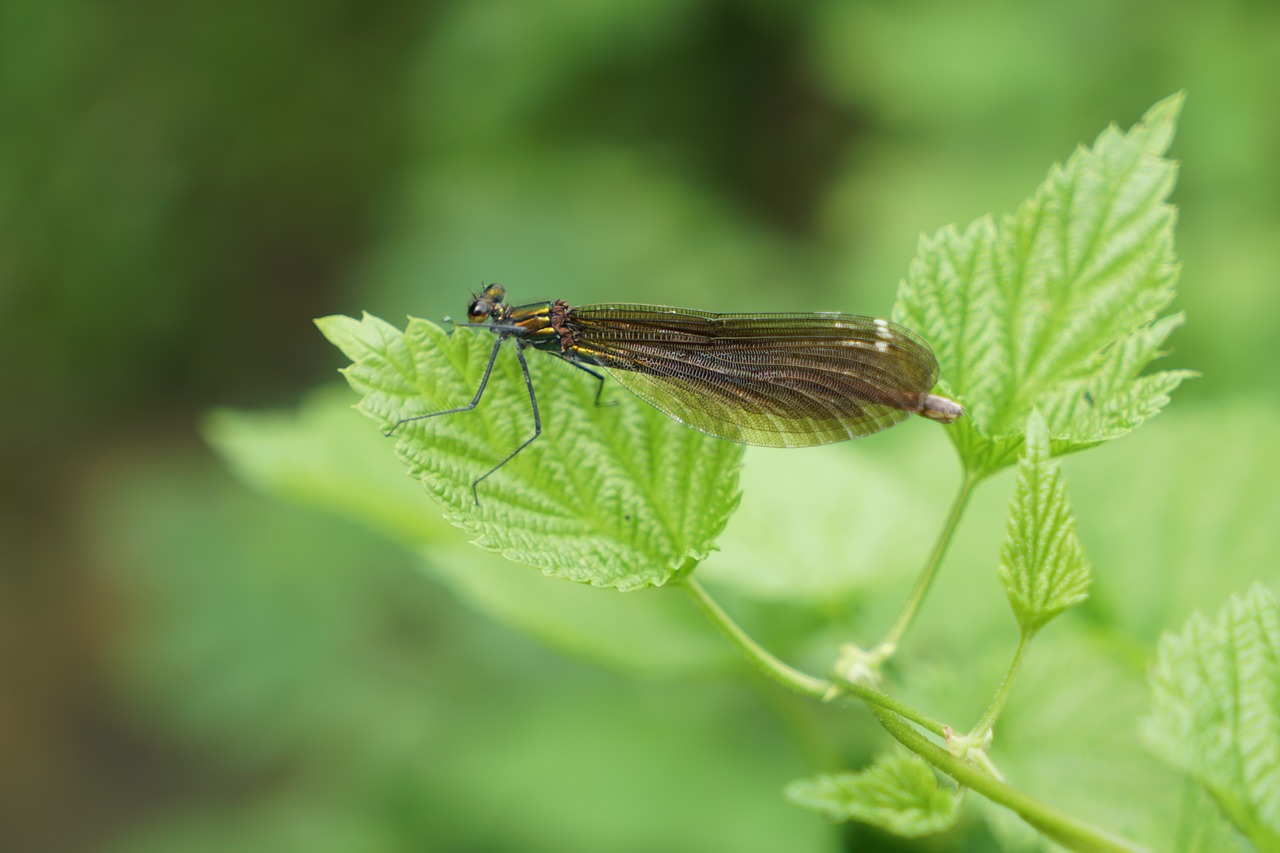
[1070, 394, 1280, 647]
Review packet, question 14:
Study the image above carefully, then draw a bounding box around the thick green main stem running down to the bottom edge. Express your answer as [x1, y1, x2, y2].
[872, 707, 1144, 853]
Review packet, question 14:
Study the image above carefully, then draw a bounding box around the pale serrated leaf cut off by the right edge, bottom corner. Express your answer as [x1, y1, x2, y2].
[1142, 585, 1280, 850]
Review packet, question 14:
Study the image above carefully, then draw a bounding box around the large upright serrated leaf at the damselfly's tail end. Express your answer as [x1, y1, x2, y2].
[895, 95, 1190, 474]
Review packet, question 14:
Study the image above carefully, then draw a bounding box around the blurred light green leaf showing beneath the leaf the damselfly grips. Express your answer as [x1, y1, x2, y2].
[204, 389, 737, 675]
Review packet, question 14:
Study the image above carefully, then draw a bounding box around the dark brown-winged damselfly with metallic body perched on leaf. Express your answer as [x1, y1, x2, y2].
[387, 284, 964, 506]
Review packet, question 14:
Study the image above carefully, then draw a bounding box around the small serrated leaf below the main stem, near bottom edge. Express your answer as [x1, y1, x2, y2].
[785, 753, 956, 838]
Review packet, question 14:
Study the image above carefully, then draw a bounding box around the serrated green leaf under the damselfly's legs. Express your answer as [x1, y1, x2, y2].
[316, 315, 742, 589]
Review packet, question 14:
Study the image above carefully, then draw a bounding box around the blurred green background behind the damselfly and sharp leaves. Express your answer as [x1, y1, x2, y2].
[0, 0, 1280, 850]
